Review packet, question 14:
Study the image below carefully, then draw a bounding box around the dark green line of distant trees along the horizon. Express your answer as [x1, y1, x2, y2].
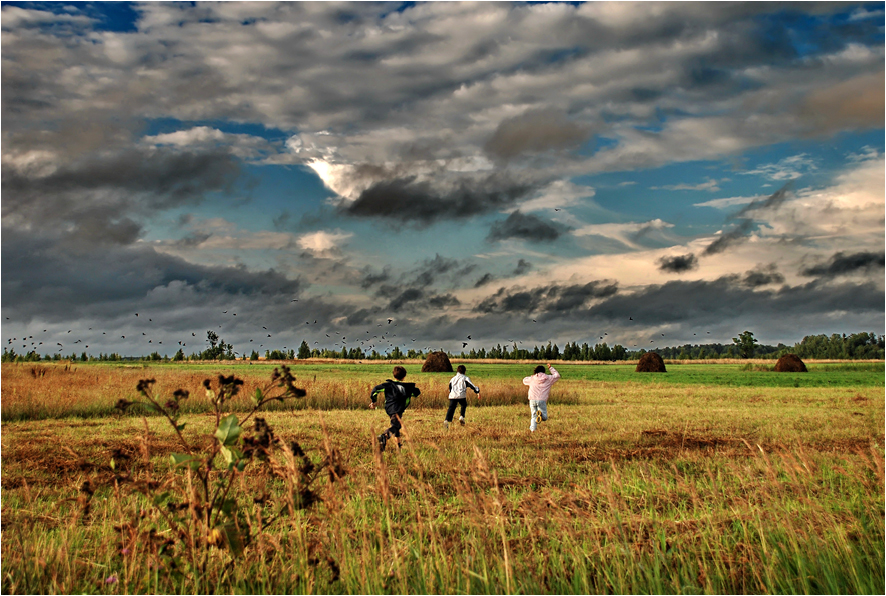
[0, 331, 886, 362]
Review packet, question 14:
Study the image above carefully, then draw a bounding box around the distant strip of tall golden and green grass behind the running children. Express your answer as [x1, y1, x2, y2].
[2, 361, 886, 421]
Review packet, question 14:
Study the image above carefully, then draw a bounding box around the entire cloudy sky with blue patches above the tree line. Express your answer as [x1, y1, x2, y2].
[0, 2, 884, 354]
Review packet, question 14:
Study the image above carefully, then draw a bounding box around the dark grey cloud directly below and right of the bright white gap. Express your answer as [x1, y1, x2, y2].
[344, 174, 537, 225]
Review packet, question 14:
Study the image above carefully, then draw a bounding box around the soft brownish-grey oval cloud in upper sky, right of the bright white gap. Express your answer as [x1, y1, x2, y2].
[483, 109, 592, 160]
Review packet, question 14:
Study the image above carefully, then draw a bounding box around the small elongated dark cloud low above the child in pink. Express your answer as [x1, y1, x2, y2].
[473, 281, 618, 313]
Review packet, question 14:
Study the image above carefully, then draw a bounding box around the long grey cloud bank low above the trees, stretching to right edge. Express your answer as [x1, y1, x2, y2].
[454, 266, 883, 348]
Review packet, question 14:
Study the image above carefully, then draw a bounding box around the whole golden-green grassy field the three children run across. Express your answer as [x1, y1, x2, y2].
[2, 363, 886, 594]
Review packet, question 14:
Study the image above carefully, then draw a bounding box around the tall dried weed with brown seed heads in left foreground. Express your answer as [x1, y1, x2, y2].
[105, 366, 345, 591]
